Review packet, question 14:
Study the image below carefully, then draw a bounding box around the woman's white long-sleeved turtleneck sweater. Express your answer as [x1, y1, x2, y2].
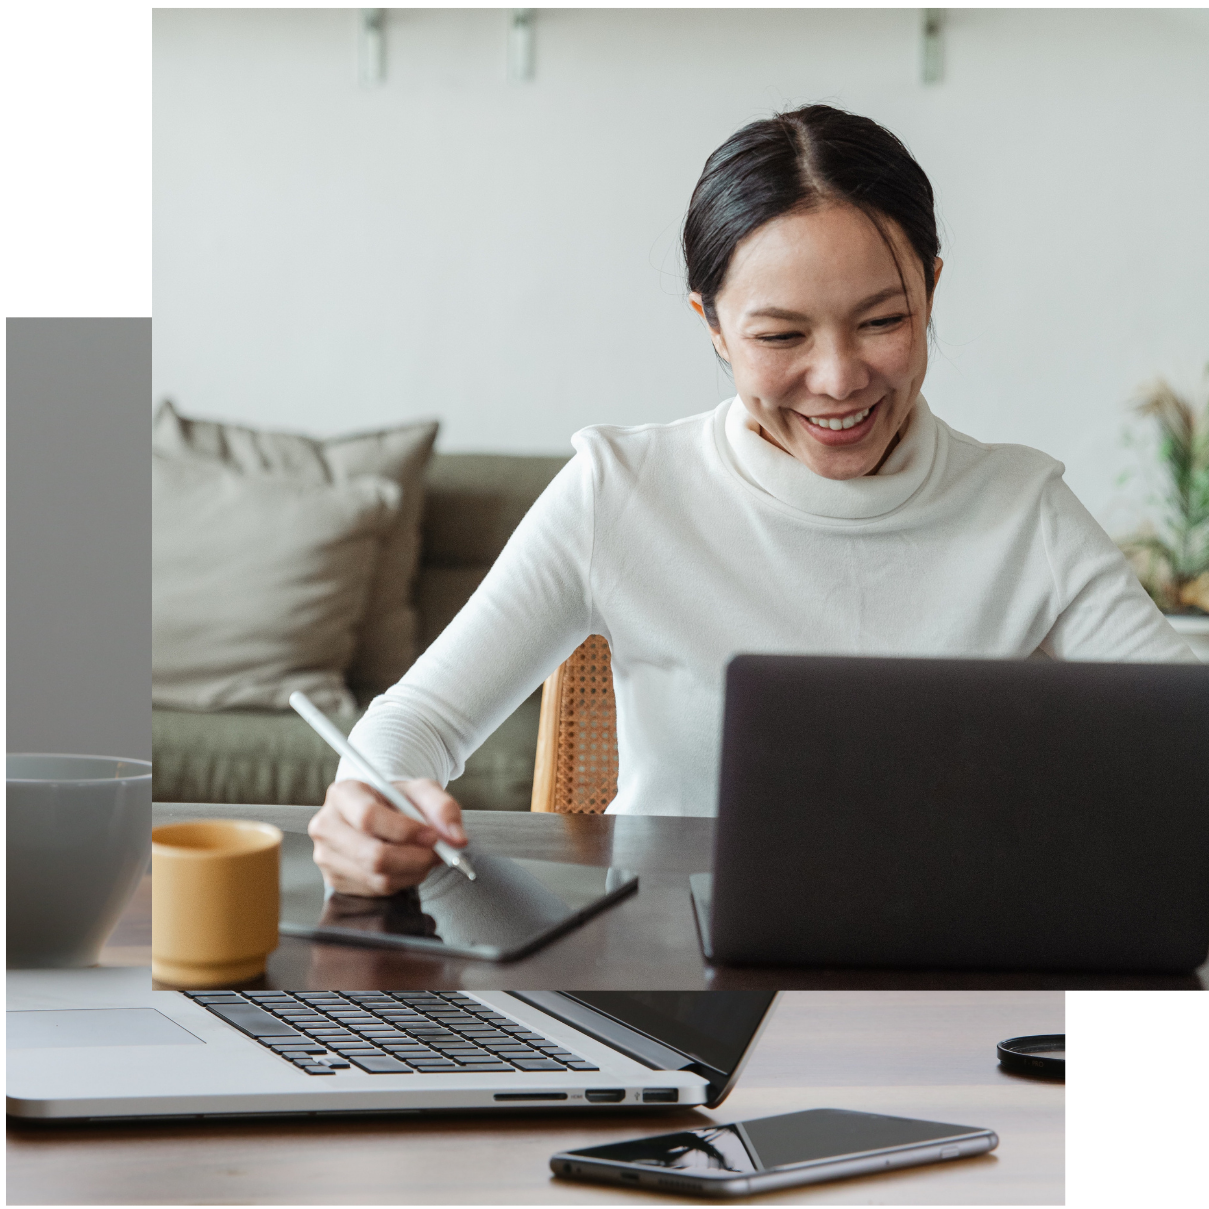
[337, 397, 1196, 815]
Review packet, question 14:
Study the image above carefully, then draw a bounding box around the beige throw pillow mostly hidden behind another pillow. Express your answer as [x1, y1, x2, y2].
[152, 401, 438, 699]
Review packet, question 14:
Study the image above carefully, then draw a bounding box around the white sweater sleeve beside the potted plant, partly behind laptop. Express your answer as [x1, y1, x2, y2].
[1041, 478, 1197, 664]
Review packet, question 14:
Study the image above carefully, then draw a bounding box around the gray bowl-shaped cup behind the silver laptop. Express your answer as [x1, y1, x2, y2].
[4, 753, 151, 968]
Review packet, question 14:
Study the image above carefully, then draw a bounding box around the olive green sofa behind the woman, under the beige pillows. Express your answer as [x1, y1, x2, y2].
[151, 453, 567, 810]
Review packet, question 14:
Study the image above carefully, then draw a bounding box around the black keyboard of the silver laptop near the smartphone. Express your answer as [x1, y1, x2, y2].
[184, 990, 600, 1075]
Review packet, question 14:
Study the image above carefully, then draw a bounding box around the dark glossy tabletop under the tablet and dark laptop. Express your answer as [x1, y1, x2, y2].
[148, 804, 1202, 990]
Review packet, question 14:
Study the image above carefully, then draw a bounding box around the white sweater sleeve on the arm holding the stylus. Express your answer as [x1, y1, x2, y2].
[336, 451, 595, 785]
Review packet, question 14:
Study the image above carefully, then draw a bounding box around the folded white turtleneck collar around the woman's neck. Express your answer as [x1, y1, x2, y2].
[718, 395, 937, 521]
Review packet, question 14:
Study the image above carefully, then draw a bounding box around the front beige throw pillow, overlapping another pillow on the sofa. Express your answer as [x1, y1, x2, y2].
[151, 455, 400, 712]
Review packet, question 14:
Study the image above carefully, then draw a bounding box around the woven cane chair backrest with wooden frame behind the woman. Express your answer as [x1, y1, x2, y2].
[531, 634, 617, 815]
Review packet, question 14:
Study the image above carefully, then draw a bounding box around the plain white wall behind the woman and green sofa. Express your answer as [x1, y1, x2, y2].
[154, 7, 1209, 530]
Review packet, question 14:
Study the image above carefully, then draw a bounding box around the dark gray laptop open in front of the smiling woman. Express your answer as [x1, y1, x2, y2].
[692, 655, 1209, 972]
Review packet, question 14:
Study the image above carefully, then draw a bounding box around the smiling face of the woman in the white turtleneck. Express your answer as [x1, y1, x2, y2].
[690, 204, 941, 479]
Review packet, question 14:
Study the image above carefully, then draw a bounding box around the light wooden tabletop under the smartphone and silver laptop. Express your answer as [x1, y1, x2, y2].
[6, 991, 1066, 1205]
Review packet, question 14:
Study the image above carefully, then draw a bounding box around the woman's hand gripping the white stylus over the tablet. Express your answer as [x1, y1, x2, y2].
[307, 780, 467, 896]
